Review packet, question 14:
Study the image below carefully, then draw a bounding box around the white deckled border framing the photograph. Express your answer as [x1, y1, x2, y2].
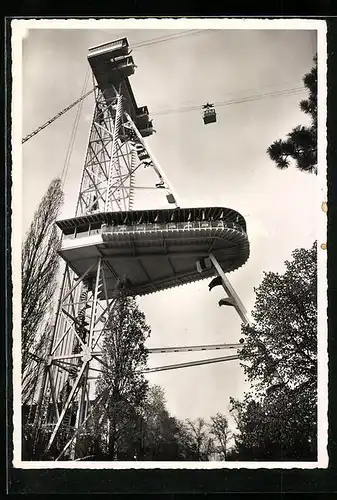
[11, 18, 328, 470]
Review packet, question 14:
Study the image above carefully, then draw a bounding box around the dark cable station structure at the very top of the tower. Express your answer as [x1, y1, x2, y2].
[88, 38, 153, 137]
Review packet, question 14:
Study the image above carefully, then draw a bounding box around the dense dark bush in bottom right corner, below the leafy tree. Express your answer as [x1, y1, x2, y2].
[227, 384, 317, 461]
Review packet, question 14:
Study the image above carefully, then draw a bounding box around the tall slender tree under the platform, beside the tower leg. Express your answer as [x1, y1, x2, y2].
[92, 294, 150, 460]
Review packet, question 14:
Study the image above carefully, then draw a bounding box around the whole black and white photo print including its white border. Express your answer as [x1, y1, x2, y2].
[11, 19, 328, 469]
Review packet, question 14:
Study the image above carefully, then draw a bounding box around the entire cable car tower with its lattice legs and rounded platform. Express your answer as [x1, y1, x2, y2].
[28, 38, 249, 459]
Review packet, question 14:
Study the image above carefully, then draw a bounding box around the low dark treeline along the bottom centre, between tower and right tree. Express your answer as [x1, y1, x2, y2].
[83, 385, 230, 461]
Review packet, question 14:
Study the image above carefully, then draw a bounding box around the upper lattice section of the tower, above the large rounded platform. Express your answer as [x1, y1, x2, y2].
[76, 88, 172, 216]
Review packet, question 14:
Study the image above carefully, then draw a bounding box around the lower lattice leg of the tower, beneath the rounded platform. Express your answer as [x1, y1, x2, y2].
[35, 257, 123, 460]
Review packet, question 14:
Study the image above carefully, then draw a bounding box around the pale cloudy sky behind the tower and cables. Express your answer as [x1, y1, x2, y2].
[17, 21, 320, 432]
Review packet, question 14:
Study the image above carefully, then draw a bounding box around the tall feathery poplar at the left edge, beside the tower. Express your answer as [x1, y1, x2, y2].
[21, 179, 63, 401]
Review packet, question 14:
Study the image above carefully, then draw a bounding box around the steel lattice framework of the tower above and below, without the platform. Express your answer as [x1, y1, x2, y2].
[29, 39, 173, 458]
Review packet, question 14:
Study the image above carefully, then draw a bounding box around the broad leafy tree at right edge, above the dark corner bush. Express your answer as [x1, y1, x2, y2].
[240, 243, 317, 390]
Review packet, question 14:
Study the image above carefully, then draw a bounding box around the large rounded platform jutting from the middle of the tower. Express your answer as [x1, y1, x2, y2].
[57, 207, 249, 297]
